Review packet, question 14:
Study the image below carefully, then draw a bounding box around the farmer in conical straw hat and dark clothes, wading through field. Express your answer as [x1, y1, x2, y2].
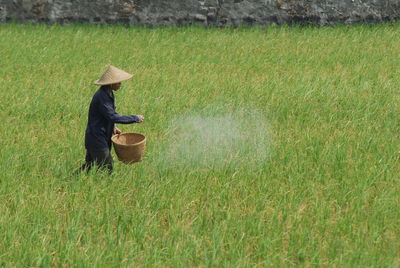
[80, 66, 144, 173]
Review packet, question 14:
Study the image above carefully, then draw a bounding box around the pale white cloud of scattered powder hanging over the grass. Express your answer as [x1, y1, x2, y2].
[158, 109, 271, 168]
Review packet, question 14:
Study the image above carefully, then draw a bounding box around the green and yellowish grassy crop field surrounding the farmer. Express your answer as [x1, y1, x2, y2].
[0, 24, 400, 267]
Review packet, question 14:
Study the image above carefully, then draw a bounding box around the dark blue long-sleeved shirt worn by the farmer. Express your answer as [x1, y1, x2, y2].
[85, 86, 139, 150]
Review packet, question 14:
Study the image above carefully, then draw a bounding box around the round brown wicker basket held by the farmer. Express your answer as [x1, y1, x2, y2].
[111, 132, 146, 163]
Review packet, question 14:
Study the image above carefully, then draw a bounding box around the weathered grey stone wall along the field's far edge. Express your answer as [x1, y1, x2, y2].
[0, 0, 400, 26]
